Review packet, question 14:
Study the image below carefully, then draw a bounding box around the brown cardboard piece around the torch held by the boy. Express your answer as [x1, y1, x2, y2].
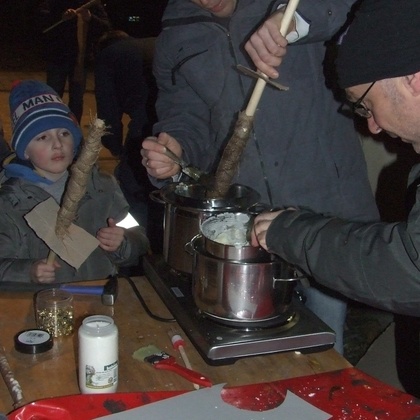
[24, 197, 99, 270]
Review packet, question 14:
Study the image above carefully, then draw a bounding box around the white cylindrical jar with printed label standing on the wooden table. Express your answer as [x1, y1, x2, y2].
[78, 315, 118, 394]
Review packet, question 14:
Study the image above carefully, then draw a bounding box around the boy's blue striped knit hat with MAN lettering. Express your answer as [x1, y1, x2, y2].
[9, 80, 83, 159]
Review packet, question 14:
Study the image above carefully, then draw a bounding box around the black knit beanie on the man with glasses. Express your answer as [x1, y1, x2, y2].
[336, 0, 420, 88]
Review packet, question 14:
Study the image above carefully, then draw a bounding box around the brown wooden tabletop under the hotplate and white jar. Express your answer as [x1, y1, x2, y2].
[0, 277, 351, 413]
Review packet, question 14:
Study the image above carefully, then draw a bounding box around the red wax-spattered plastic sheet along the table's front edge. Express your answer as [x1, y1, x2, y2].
[8, 368, 420, 420]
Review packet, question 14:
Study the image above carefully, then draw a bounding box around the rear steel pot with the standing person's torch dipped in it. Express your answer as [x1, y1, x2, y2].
[151, 183, 260, 274]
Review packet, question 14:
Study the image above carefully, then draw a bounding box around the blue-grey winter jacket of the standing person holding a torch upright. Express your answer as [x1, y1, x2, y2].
[154, 0, 378, 220]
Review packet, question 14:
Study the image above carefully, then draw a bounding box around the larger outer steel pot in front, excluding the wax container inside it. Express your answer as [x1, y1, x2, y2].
[189, 235, 303, 323]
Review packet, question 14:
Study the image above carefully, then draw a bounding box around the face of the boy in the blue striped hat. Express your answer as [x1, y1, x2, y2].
[25, 128, 74, 181]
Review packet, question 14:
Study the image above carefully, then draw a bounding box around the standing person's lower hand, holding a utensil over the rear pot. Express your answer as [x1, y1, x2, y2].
[141, 133, 182, 179]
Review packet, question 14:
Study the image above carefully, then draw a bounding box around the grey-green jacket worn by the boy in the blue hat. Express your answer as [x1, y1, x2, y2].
[0, 168, 149, 284]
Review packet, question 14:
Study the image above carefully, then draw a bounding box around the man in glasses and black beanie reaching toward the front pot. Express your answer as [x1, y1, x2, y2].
[253, 0, 420, 396]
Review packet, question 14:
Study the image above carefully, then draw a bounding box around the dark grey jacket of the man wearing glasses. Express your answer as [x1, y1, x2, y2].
[266, 165, 420, 316]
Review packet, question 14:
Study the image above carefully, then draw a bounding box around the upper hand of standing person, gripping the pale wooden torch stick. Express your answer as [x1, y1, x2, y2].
[245, 10, 294, 79]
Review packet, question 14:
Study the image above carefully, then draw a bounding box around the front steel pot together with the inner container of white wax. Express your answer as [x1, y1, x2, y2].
[188, 212, 304, 326]
